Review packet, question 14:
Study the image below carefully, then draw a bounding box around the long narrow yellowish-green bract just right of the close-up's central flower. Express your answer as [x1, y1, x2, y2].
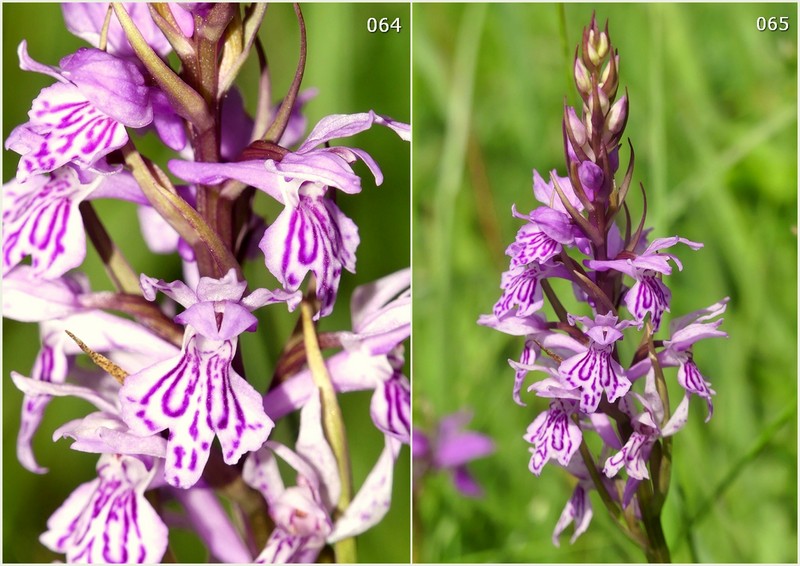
[300, 300, 356, 564]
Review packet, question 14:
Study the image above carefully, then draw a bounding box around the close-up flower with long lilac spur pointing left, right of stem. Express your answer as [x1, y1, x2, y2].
[169, 111, 410, 318]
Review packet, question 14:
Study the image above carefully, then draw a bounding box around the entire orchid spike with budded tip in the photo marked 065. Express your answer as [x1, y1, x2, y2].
[478, 17, 727, 562]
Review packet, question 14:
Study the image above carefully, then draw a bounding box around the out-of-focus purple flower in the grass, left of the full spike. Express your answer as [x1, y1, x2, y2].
[412, 411, 495, 497]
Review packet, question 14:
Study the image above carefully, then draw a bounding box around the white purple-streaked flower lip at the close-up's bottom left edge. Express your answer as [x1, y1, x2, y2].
[39, 454, 167, 564]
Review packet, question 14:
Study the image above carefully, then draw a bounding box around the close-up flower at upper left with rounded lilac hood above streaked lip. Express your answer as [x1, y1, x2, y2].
[6, 41, 153, 182]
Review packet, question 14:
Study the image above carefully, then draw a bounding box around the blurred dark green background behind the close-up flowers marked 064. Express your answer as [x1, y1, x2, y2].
[2, 4, 410, 562]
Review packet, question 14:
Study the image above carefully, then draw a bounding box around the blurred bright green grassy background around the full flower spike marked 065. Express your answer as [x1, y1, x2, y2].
[413, 3, 797, 563]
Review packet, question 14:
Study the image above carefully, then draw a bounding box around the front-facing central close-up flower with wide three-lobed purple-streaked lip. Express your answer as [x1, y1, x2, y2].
[120, 270, 300, 488]
